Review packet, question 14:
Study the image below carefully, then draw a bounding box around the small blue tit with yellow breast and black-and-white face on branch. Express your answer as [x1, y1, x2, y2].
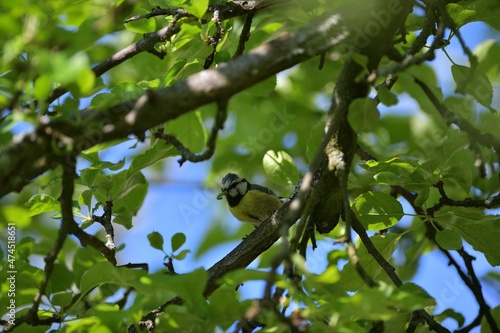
[217, 173, 281, 227]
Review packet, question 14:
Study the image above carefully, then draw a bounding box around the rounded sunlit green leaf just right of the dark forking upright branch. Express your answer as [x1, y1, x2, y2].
[352, 191, 404, 230]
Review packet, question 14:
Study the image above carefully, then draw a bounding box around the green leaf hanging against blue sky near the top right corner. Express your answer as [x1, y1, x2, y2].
[451, 65, 496, 112]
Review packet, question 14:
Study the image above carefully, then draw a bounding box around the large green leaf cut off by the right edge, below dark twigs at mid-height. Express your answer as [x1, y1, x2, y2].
[434, 207, 500, 266]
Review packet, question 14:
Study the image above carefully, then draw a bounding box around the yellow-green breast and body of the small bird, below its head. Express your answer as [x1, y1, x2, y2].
[229, 190, 281, 226]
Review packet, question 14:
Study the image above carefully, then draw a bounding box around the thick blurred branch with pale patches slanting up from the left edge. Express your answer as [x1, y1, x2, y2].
[0, 12, 355, 196]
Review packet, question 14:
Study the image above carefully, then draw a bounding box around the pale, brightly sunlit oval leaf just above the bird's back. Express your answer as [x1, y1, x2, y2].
[262, 150, 300, 186]
